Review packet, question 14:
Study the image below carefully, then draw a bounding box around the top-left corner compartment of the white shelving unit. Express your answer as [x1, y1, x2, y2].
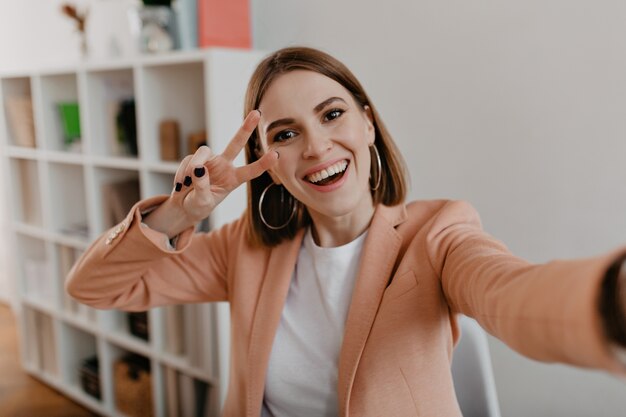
[0, 77, 37, 148]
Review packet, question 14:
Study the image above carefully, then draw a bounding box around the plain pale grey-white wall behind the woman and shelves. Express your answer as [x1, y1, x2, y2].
[0, 0, 626, 417]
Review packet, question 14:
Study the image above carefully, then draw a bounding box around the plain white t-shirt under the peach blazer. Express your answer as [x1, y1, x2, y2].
[261, 228, 367, 417]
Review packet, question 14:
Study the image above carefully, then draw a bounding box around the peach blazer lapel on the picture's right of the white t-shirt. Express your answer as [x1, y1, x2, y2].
[337, 205, 406, 416]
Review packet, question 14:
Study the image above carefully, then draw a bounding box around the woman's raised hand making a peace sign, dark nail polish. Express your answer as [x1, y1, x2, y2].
[144, 111, 278, 238]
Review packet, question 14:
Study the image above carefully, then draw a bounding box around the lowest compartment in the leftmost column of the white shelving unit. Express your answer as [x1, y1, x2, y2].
[22, 307, 59, 379]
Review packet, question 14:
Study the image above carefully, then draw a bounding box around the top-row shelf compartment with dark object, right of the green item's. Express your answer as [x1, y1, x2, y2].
[86, 68, 137, 158]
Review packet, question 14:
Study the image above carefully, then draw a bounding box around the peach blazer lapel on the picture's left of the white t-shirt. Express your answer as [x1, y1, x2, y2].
[246, 230, 304, 417]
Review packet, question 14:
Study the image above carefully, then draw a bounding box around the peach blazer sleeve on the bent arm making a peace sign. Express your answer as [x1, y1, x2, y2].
[66, 196, 242, 311]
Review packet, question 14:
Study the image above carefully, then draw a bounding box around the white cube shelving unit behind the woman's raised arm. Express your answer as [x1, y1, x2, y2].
[0, 49, 262, 416]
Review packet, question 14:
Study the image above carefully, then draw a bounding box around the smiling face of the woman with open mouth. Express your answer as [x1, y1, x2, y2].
[258, 70, 375, 220]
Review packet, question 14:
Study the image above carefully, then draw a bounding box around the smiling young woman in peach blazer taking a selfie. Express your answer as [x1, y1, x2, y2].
[67, 48, 626, 417]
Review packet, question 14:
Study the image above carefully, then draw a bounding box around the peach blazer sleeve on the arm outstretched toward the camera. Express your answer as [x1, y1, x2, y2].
[427, 201, 626, 374]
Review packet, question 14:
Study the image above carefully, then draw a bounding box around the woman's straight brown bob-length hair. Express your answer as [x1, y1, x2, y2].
[244, 47, 407, 247]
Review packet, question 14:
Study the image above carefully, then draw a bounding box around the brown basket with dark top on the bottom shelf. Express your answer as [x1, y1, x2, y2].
[113, 353, 154, 417]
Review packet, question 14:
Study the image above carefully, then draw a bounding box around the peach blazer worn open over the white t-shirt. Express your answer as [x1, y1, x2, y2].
[67, 197, 624, 417]
